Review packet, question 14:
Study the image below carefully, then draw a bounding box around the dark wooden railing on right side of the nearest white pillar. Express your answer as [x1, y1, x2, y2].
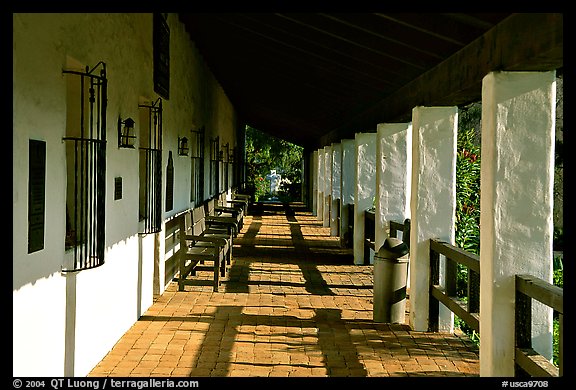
[515, 275, 564, 376]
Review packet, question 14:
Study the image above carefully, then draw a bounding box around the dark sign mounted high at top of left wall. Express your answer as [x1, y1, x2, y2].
[153, 13, 170, 100]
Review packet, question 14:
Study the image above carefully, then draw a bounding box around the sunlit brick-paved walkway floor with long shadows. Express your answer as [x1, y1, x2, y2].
[89, 203, 479, 377]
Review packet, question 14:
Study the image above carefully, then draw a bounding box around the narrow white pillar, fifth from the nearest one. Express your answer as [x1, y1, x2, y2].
[340, 139, 356, 246]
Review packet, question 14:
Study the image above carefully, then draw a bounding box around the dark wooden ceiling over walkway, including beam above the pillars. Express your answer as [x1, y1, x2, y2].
[180, 13, 562, 148]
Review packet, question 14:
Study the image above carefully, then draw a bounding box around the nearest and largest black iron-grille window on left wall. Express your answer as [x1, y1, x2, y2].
[62, 62, 107, 272]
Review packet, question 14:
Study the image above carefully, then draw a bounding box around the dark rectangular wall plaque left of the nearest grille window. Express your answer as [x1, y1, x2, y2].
[28, 139, 46, 253]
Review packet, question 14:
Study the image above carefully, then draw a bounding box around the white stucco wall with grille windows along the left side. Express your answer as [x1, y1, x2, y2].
[12, 13, 235, 376]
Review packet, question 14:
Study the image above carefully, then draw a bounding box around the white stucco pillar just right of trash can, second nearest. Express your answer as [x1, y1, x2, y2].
[410, 107, 458, 332]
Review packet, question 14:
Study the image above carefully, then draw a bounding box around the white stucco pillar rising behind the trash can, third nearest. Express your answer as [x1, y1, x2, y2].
[375, 123, 412, 251]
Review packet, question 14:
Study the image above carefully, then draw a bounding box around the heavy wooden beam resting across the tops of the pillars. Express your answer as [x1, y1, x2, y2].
[317, 13, 563, 147]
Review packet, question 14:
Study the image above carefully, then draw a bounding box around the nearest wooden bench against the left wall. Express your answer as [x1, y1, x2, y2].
[178, 206, 233, 292]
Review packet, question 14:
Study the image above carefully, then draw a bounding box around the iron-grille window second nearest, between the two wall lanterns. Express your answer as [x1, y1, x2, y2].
[138, 98, 162, 234]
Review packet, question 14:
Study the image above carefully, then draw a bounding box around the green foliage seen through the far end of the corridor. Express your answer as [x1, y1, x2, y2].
[246, 126, 304, 201]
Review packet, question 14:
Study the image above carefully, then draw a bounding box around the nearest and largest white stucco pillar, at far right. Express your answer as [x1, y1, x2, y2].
[480, 71, 556, 376]
